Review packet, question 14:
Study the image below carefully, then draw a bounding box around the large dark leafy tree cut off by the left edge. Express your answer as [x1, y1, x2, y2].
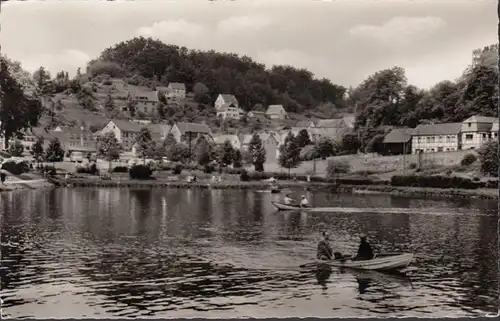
[0, 58, 43, 148]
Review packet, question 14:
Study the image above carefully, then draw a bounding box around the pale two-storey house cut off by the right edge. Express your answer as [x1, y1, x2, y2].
[461, 116, 498, 150]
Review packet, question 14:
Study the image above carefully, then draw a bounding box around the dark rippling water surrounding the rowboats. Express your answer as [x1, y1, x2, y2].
[0, 188, 499, 318]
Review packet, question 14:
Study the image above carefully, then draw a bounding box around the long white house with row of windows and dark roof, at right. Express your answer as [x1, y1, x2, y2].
[411, 123, 462, 154]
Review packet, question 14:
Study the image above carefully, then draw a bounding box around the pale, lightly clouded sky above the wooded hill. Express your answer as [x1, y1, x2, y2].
[0, 0, 498, 88]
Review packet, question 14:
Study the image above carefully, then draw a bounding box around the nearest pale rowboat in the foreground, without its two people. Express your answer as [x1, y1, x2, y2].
[316, 253, 413, 271]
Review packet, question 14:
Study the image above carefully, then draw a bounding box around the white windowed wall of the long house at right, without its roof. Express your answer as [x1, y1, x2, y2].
[411, 135, 461, 154]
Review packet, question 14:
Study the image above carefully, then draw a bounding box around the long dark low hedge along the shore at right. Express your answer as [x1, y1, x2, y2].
[391, 175, 482, 189]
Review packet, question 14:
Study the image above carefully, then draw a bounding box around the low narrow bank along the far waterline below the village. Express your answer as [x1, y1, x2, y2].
[50, 178, 499, 199]
